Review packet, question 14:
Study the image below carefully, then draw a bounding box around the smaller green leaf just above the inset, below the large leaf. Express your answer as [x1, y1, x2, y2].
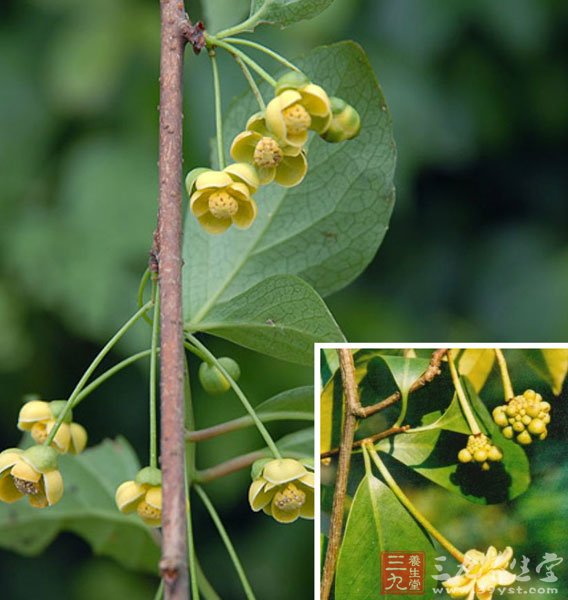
[186, 275, 345, 365]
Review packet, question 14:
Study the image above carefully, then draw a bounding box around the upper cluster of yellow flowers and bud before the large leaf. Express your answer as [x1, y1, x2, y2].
[186, 71, 361, 234]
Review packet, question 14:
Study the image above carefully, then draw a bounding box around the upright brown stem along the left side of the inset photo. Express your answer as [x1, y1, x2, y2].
[320, 348, 361, 600]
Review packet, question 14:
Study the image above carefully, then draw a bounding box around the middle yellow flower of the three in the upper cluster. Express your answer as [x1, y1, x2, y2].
[231, 113, 308, 187]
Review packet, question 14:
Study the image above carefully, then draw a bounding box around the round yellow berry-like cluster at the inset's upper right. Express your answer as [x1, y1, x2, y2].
[493, 390, 550, 446]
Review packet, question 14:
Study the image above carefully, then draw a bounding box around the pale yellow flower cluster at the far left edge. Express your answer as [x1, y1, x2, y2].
[0, 400, 87, 508]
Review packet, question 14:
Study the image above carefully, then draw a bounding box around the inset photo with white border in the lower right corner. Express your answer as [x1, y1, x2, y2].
[322, 344, 568, 600]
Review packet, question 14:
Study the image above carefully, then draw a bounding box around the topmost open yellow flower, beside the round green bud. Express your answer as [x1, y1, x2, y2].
[265, 83, 331, 148]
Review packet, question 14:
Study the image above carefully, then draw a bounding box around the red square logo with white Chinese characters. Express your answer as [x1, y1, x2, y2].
[381, 552, 424, 595]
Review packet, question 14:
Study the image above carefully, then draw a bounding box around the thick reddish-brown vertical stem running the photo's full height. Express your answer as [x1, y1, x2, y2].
[153, 0, 189, 600]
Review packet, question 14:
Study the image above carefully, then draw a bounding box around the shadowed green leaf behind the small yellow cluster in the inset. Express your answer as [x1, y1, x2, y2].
[408, 379, 530, 504]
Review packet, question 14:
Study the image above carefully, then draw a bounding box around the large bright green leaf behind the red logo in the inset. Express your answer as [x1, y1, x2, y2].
[335, 475, 436, 600]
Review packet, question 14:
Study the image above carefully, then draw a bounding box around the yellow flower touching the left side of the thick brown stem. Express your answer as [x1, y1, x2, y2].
[115, 467, 162, 527]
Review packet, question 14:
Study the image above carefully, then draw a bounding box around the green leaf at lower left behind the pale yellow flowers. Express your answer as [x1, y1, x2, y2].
[0, 438, 160, 573]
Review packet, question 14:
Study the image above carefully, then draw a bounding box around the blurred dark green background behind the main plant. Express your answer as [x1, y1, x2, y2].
[0, 0, 568, 599]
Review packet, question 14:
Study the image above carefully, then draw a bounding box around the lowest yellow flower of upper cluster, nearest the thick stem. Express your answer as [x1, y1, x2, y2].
[186, 163, 259, 233]
